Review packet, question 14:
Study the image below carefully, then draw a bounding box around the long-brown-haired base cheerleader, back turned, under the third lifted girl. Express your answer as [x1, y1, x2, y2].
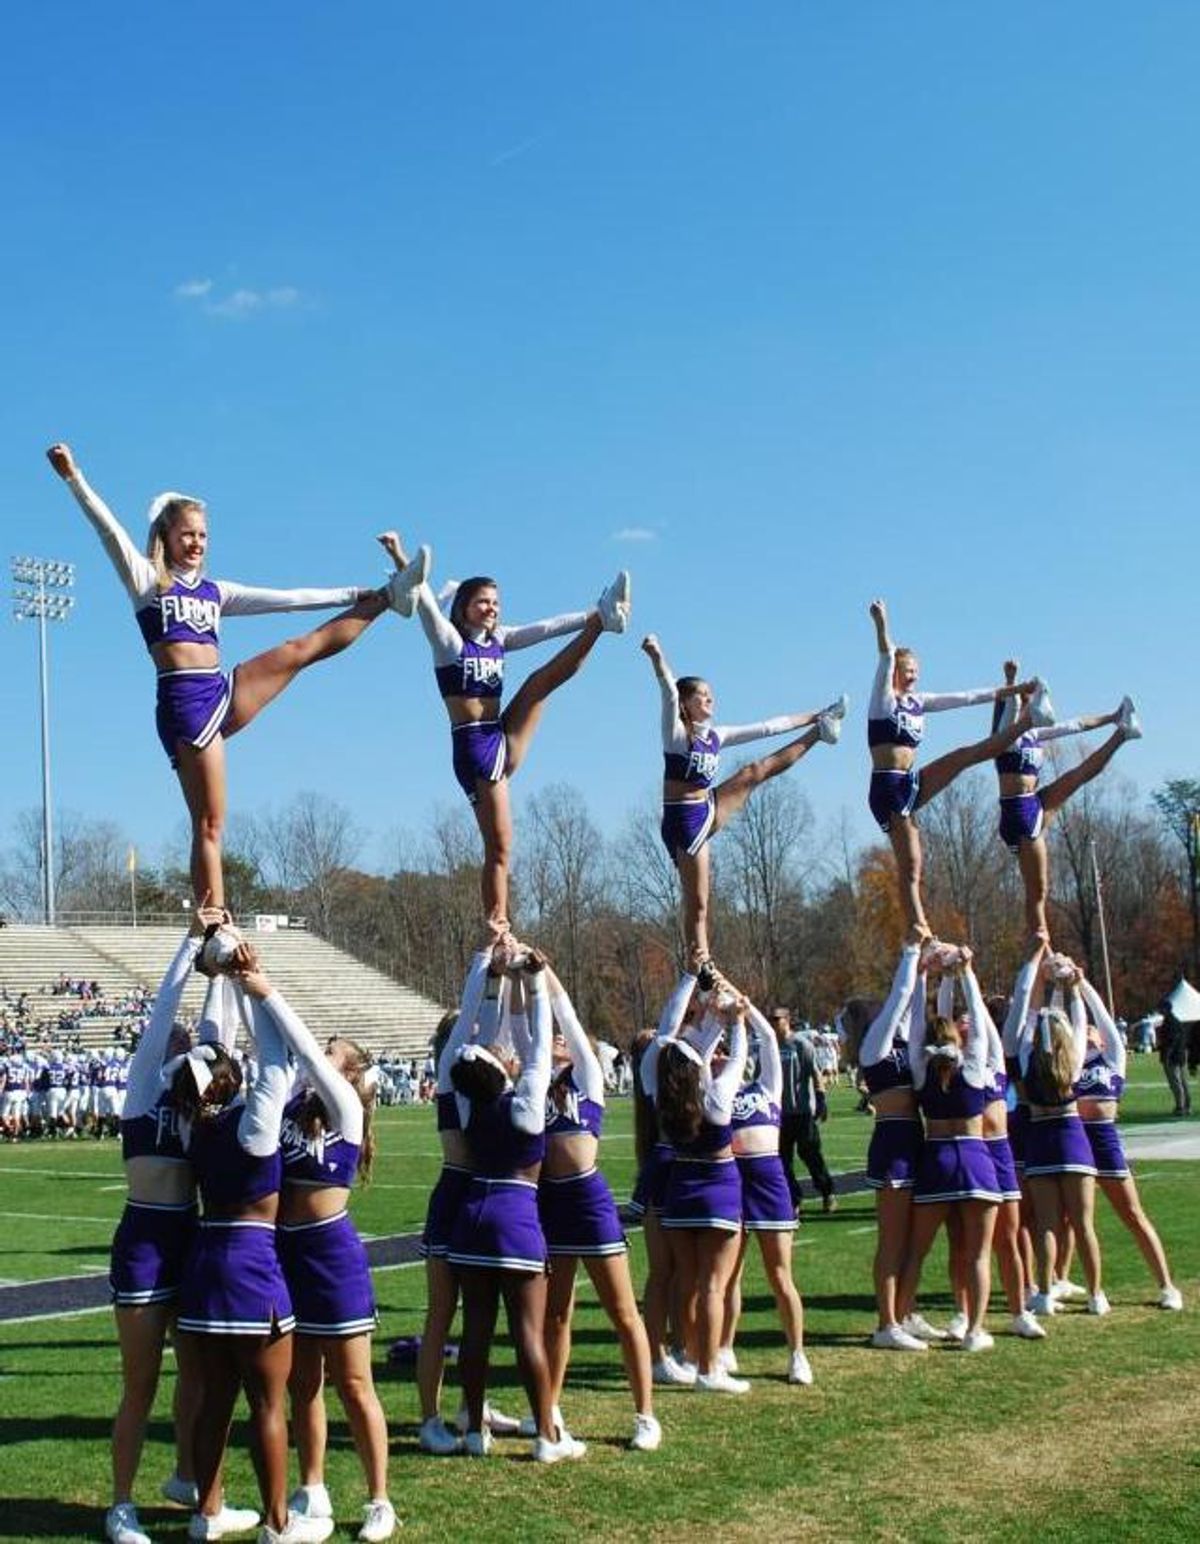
[642, 990, 751, 1394]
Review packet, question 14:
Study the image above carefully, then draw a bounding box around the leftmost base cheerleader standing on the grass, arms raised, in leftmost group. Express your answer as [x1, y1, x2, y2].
[105, 906, 247, 1544]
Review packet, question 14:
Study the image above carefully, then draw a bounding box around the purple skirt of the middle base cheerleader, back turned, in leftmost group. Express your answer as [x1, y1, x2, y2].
[178, 1221, 295, 1336]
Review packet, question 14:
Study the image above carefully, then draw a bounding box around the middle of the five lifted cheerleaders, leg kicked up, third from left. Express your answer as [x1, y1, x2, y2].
[641, 633, 848, 963]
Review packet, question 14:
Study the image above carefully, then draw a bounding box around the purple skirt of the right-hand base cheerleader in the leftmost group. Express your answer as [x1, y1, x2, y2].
[276, 1212, 378, 1340]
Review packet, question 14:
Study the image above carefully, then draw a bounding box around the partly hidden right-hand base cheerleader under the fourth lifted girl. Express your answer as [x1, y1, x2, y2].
[937, 960, 1046, 1342]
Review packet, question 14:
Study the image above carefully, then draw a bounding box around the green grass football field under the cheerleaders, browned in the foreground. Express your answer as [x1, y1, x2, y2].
[0, 1080, 1200, 1541]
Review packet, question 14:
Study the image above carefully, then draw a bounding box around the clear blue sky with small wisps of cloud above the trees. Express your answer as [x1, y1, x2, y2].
[0, 0, 1200, 863]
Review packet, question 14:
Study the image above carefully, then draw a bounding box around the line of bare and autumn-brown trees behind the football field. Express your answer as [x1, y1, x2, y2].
[0, 772, 1200, 1044]
